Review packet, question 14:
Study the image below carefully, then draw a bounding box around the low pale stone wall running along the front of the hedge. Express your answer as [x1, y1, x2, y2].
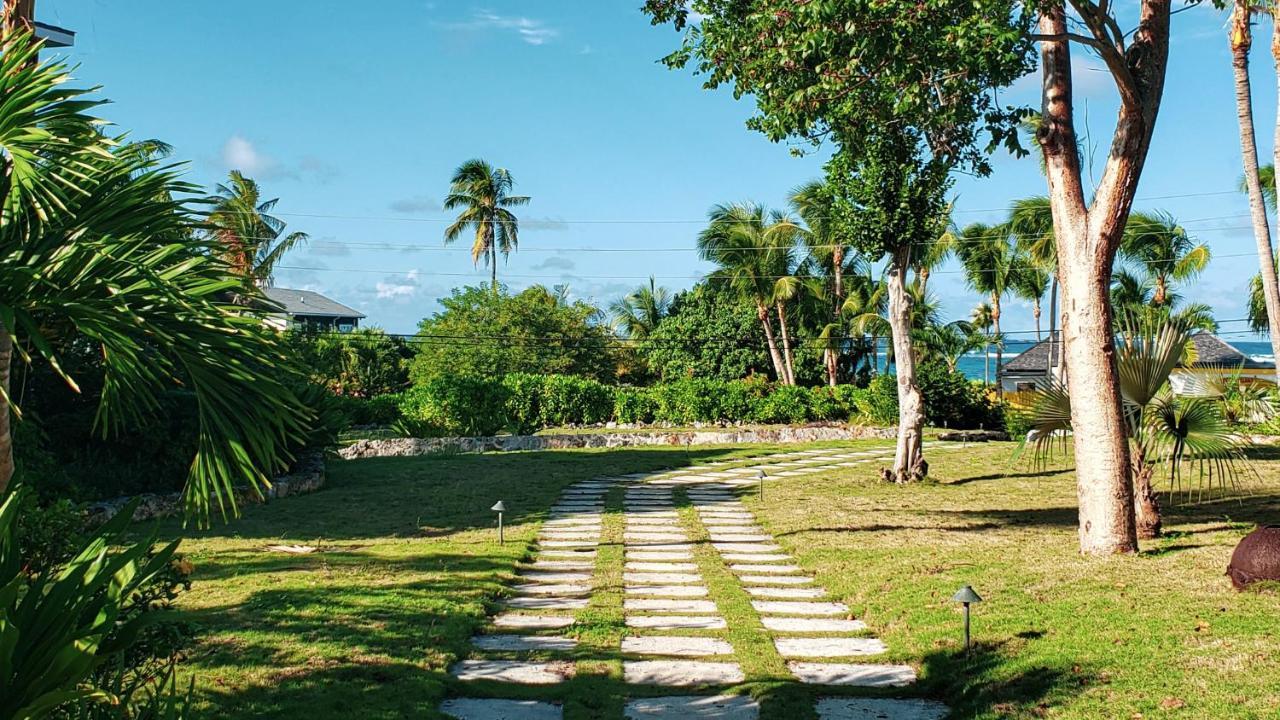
[338, 425, 897, 460]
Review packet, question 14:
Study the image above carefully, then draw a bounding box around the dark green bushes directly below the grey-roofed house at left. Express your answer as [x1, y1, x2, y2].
[284, 328, 413, 397]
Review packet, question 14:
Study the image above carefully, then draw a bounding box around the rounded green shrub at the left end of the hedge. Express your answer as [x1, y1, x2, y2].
[399, 375, 508, 436]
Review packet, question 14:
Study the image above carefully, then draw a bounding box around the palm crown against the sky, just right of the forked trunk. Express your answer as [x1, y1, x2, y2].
[1120, 213, 1210, 305]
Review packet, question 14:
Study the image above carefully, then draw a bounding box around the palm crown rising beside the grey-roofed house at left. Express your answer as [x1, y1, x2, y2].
[209, 170, 307, 287]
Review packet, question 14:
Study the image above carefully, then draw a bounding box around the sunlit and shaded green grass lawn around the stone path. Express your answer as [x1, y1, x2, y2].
[165, 442, 1280, 720]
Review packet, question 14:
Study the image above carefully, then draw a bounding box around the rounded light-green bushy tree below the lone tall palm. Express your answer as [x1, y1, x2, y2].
[410, 286, 618, 384]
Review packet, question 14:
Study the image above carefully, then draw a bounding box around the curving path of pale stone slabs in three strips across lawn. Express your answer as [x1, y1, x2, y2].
[440, 443, 959, 720]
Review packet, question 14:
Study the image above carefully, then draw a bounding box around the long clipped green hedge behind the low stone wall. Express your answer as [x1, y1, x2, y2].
[398, 368, 1000, 437]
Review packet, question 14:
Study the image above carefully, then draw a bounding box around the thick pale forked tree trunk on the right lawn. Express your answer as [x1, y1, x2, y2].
[1038, 0, 1170, 555]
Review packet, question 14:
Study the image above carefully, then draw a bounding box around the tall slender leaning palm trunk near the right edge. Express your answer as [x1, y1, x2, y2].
[1230, 0, 1280, 384]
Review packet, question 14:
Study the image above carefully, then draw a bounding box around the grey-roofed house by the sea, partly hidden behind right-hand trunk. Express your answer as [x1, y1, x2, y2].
[1000, 332, 1275, 395]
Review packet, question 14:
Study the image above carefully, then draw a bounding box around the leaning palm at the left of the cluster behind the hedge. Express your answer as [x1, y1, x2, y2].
[698, 205, 795, 384]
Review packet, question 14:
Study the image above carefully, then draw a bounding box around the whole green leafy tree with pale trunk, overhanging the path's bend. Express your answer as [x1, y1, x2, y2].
[644, 0, 1033, 482]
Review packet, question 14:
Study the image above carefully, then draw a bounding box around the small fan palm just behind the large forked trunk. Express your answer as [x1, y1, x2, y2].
[1028, 322, 1245, 538]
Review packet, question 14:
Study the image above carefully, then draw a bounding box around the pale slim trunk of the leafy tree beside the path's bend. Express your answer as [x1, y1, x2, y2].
[882, 246, 929, 483]
